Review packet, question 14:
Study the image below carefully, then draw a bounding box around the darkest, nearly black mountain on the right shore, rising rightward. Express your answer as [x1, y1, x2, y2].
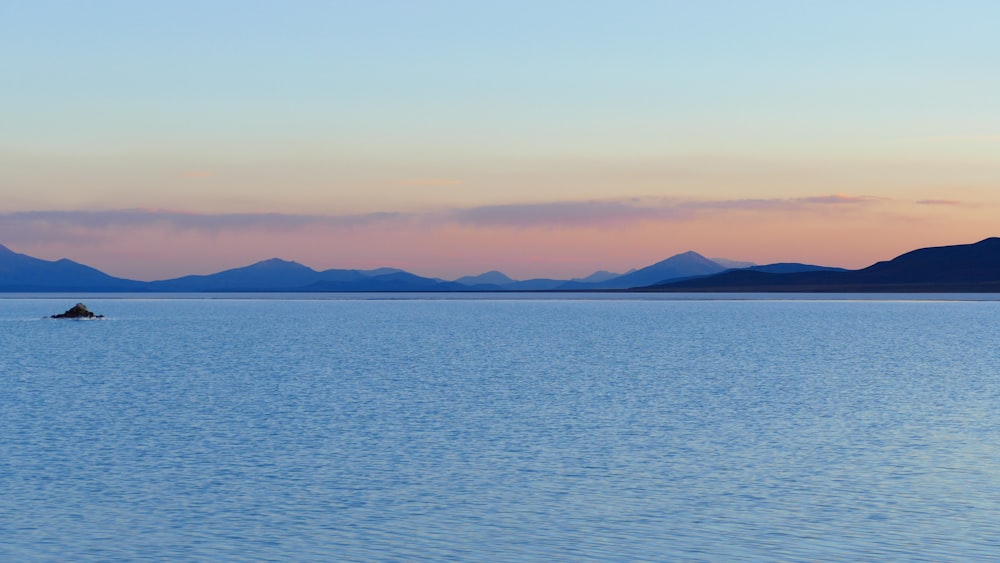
[643, 238, 1000, 292]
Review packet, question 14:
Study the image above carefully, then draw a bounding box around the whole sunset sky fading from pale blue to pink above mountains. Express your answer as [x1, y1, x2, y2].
[0, 0, 1000, 280]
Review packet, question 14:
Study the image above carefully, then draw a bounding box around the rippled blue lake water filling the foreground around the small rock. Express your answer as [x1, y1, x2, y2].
[0, 297, 1000, 561]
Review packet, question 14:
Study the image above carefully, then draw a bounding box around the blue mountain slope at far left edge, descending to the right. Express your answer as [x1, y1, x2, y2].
[0, 245, 143, 291]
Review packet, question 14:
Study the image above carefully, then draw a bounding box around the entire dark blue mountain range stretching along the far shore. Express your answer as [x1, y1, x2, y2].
[0, 238, 1000, 292]
